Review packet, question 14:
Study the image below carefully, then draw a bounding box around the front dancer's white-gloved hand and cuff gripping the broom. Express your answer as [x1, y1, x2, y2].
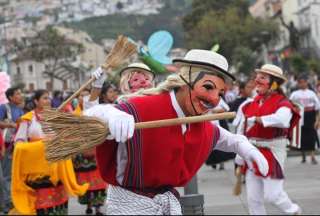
[84, 104, 134, 143]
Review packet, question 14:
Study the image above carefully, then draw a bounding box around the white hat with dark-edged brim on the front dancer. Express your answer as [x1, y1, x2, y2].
[173, 49, 235, 80]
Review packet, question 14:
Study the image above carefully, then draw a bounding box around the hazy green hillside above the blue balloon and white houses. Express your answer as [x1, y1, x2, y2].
[64, 0, 192, 47]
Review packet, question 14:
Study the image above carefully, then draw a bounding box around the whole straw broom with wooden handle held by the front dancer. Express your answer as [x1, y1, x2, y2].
[41, 110, 235, 162]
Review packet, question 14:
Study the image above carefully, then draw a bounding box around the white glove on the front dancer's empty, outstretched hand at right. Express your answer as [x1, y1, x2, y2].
[245, 149, 269, 176]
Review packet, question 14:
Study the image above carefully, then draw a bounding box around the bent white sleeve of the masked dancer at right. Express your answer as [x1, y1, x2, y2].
[261, 107, 292, 128]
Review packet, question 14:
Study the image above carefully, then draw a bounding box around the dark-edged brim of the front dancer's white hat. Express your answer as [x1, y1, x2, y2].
[173, 59, 236, 81]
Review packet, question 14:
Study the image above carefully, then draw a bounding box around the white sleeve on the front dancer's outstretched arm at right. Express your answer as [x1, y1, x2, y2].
[214, 127, 256, 159]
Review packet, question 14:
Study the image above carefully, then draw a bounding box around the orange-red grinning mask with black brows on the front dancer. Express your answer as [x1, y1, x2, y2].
[186, 73, 225, 115]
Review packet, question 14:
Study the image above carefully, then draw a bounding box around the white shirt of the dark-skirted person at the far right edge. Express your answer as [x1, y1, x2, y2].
[290, 89, 320, 110]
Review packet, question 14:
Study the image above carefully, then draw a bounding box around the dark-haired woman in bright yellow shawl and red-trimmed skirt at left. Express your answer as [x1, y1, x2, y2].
[12, 90, 88, 215]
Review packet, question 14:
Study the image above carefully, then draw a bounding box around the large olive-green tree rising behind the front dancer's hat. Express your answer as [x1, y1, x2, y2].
[183, 0, 278, 75]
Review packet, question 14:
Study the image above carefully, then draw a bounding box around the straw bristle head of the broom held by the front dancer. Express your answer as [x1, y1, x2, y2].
[41, 110, 109, 162]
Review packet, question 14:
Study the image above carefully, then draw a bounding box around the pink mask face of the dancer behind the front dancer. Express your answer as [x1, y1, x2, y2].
[129, 71, 153, 93]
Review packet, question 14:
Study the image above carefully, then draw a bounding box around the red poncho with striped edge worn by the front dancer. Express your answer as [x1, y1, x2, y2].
[97, 93, 220, 188]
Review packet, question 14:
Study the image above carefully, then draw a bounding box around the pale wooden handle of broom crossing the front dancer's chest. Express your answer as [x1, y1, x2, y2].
[135, 112, 236, 129]
